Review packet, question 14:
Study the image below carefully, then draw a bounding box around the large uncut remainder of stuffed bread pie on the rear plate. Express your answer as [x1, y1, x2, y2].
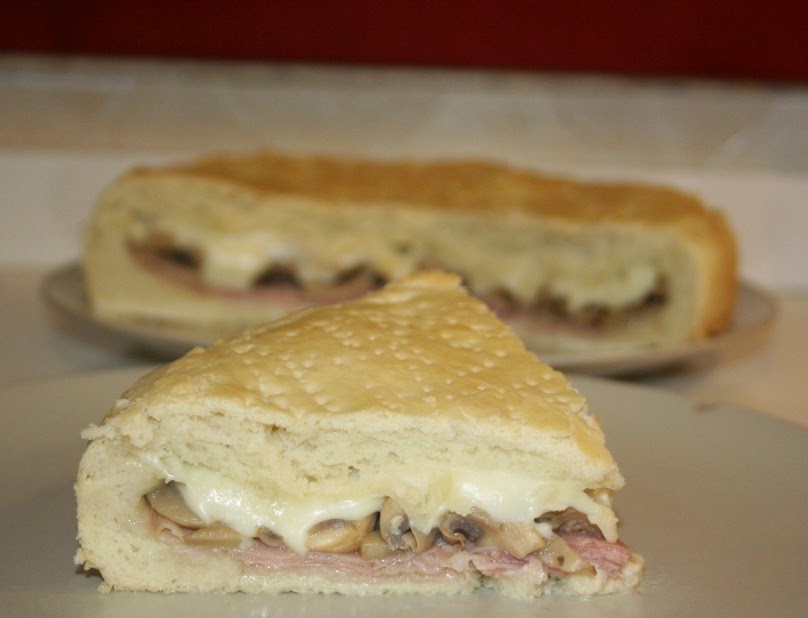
[83, 152, 737, 352]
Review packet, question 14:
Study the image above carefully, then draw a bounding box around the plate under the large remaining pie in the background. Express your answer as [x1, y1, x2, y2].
[42, 264, 776, 376]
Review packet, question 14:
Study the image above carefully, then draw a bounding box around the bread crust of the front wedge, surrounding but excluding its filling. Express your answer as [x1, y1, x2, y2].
[76, 272, 640, 598]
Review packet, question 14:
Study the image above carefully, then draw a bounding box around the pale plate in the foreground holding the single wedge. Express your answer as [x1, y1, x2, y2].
[0, 368, 808, 618]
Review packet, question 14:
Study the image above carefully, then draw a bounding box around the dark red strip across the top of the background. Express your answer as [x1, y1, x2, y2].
[0, 0, 808, 81]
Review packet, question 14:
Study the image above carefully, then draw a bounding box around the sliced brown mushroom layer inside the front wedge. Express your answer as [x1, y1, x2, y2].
[145, 481, 603, 574]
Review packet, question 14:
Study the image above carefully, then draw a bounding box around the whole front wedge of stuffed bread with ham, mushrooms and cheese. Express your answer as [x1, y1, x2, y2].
[76, 272, 643, 599]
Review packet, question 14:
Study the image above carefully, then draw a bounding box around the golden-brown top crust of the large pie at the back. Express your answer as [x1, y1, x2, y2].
[136, 151, 724, 229]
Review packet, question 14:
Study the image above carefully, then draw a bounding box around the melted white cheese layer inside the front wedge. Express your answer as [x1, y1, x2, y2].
[145, 456, 617, 554]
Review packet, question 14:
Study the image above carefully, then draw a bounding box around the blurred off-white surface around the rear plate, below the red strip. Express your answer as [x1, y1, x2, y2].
[0, 55, 808, 427]
